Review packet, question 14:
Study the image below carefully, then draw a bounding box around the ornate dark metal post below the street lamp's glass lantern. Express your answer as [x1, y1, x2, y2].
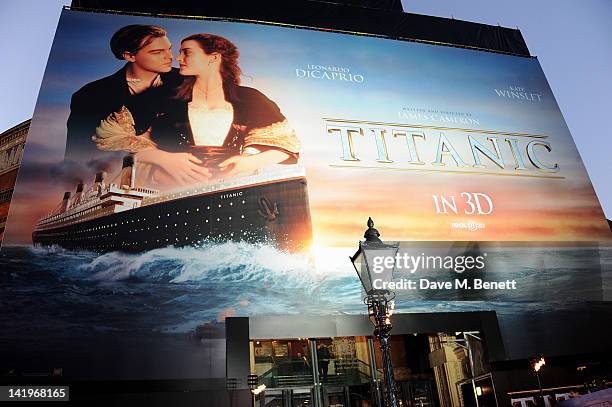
[366, 295, 399, 407]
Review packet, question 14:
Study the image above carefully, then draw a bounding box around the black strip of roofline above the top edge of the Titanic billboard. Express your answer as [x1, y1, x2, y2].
[71, 0, 530, 56]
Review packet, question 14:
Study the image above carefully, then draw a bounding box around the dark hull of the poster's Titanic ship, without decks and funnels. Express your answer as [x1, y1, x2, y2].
[32, 177, 312, 252]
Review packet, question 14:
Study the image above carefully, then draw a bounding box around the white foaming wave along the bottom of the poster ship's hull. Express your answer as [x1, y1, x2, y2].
[72, 242, 324, 288]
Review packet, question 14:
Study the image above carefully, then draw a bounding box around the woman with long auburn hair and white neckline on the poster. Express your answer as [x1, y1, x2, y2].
[94, 34, 300, 185]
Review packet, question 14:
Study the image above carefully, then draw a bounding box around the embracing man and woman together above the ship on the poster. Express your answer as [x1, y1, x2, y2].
[65, 25, 300, 187]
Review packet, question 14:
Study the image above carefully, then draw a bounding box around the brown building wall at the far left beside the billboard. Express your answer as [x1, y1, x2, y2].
[0, 120, 30, 243]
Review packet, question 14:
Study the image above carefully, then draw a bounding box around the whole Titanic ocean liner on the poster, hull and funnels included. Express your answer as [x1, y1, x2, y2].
[32, 156, 312, 252]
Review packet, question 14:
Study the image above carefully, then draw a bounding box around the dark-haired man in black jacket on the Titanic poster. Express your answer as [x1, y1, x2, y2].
[65, 24, 182, 160]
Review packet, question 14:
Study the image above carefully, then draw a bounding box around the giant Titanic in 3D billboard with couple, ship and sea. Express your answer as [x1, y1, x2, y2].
[2, 10, 610, 377]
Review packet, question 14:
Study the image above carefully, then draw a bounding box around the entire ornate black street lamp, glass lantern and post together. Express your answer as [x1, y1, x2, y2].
[351, 218, 399, 407]
